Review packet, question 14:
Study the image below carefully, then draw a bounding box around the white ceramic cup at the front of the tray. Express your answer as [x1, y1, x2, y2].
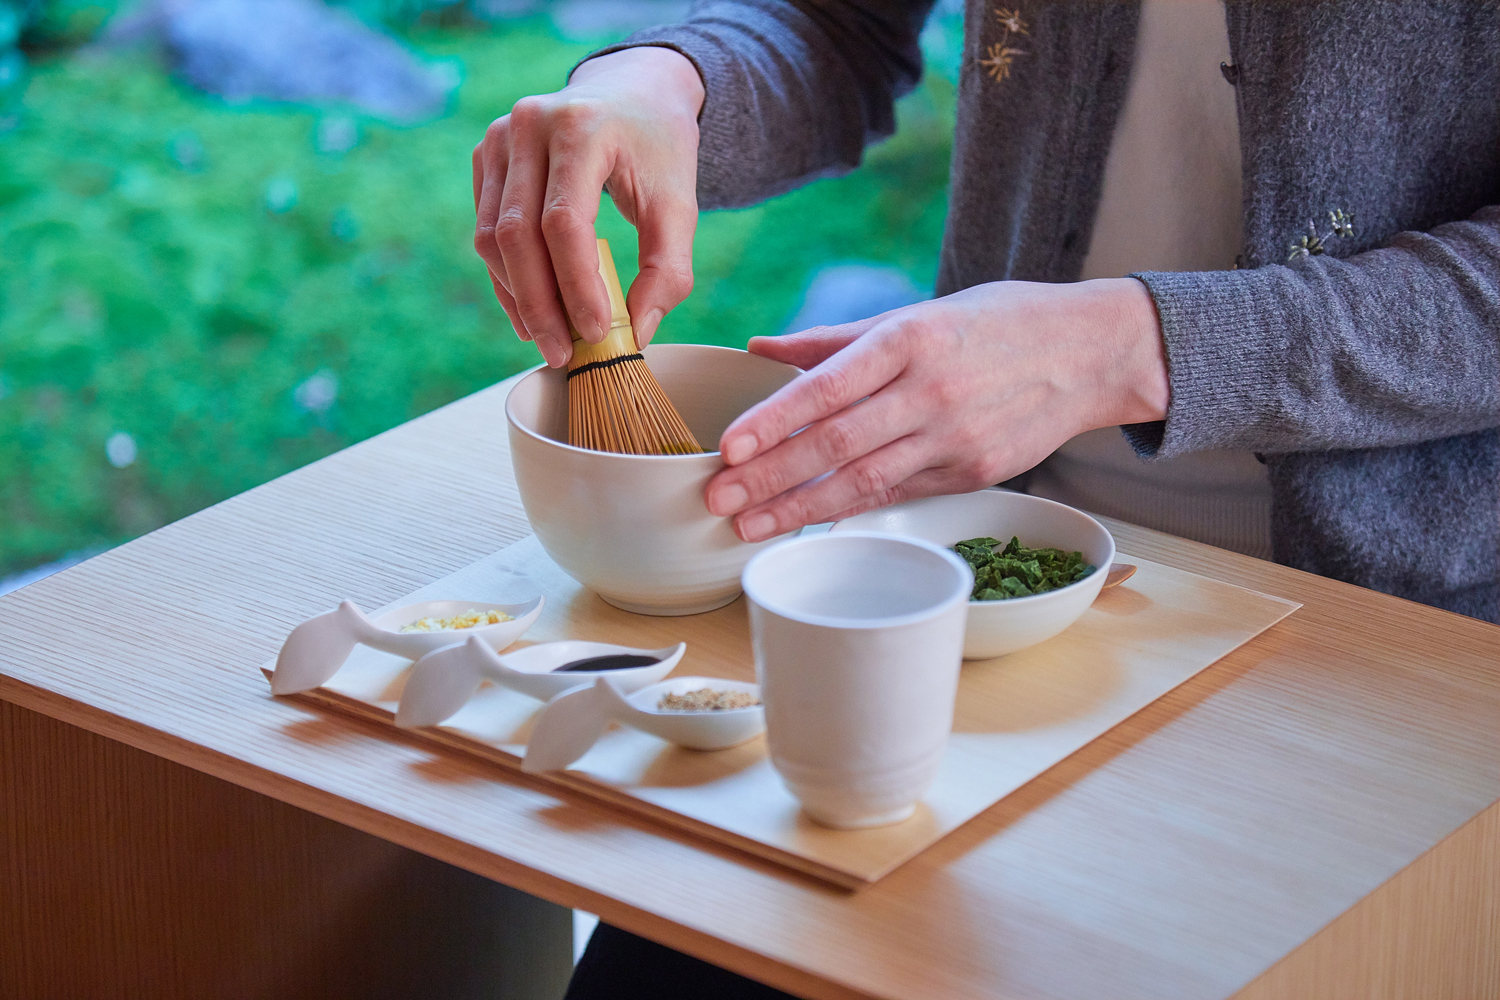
[743, 532, 974, 829]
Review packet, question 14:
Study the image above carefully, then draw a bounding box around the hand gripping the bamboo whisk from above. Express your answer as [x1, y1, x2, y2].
[474, 46, 704, 367]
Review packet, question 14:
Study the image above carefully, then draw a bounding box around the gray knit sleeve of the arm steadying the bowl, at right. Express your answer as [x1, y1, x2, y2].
[1125, 207, 1500, 457]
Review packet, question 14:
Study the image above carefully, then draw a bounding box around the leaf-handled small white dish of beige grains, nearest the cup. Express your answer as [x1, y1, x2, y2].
[521, 676, 765, 774]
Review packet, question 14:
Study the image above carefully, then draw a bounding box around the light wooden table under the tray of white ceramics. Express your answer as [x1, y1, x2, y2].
[0, 377, 1500, 1000]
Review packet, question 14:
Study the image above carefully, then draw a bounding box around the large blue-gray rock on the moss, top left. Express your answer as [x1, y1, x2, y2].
[108, 0, 456, 123]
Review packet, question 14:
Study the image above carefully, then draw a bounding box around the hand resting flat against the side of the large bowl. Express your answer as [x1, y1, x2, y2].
[705, 277, 1169, 541]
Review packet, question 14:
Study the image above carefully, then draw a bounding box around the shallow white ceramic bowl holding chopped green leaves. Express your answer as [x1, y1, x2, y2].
[833, 490, 1115, 660]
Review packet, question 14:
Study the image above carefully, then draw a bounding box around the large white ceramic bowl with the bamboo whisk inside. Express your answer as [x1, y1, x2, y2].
[506, 343, 801, 615]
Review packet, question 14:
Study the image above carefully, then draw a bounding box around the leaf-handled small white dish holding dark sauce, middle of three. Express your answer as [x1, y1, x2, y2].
[396, 639, 687, 727]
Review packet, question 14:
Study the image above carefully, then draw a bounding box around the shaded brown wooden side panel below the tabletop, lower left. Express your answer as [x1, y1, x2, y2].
[0, 702, 573, 1000]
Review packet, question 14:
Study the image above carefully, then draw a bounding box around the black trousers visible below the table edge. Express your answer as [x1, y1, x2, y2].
[566, 924, 794, 1000]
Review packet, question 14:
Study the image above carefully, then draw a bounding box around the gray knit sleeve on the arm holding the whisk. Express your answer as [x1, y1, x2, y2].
[573, 0, 932, 208]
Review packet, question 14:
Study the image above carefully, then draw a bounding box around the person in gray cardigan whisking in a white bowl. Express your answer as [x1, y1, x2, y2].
[474, 0, 1500, 997]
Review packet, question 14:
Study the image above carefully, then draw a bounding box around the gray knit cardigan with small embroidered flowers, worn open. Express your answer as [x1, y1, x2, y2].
[591, 0, 1500, 621]
